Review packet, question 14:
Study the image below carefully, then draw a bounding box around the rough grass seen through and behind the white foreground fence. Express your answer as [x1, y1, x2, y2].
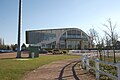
[89, 56, 120, 80]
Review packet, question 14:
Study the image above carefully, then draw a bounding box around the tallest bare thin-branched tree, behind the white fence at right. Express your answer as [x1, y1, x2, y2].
[103, 19, 118, 63]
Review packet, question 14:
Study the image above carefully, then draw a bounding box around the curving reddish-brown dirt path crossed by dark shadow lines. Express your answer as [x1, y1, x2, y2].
[24, 59, 95, 80]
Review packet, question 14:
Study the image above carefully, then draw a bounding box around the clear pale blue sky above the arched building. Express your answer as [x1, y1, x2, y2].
[0, 0, 120, 44]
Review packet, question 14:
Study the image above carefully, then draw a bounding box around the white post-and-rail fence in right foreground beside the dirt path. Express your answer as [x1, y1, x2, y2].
[82, 55, 120, 80]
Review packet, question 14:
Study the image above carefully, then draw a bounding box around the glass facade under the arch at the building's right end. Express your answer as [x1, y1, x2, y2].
[60, 30, 88, 49]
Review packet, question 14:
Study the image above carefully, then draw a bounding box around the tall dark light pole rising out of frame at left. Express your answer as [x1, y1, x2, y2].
[16, 0, 22, 58]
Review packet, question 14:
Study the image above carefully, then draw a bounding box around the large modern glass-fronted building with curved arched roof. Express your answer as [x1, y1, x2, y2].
[26, 28, 90, 49]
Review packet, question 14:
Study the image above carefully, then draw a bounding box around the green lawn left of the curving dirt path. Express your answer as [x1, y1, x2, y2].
[0, 55, 80, 80]
